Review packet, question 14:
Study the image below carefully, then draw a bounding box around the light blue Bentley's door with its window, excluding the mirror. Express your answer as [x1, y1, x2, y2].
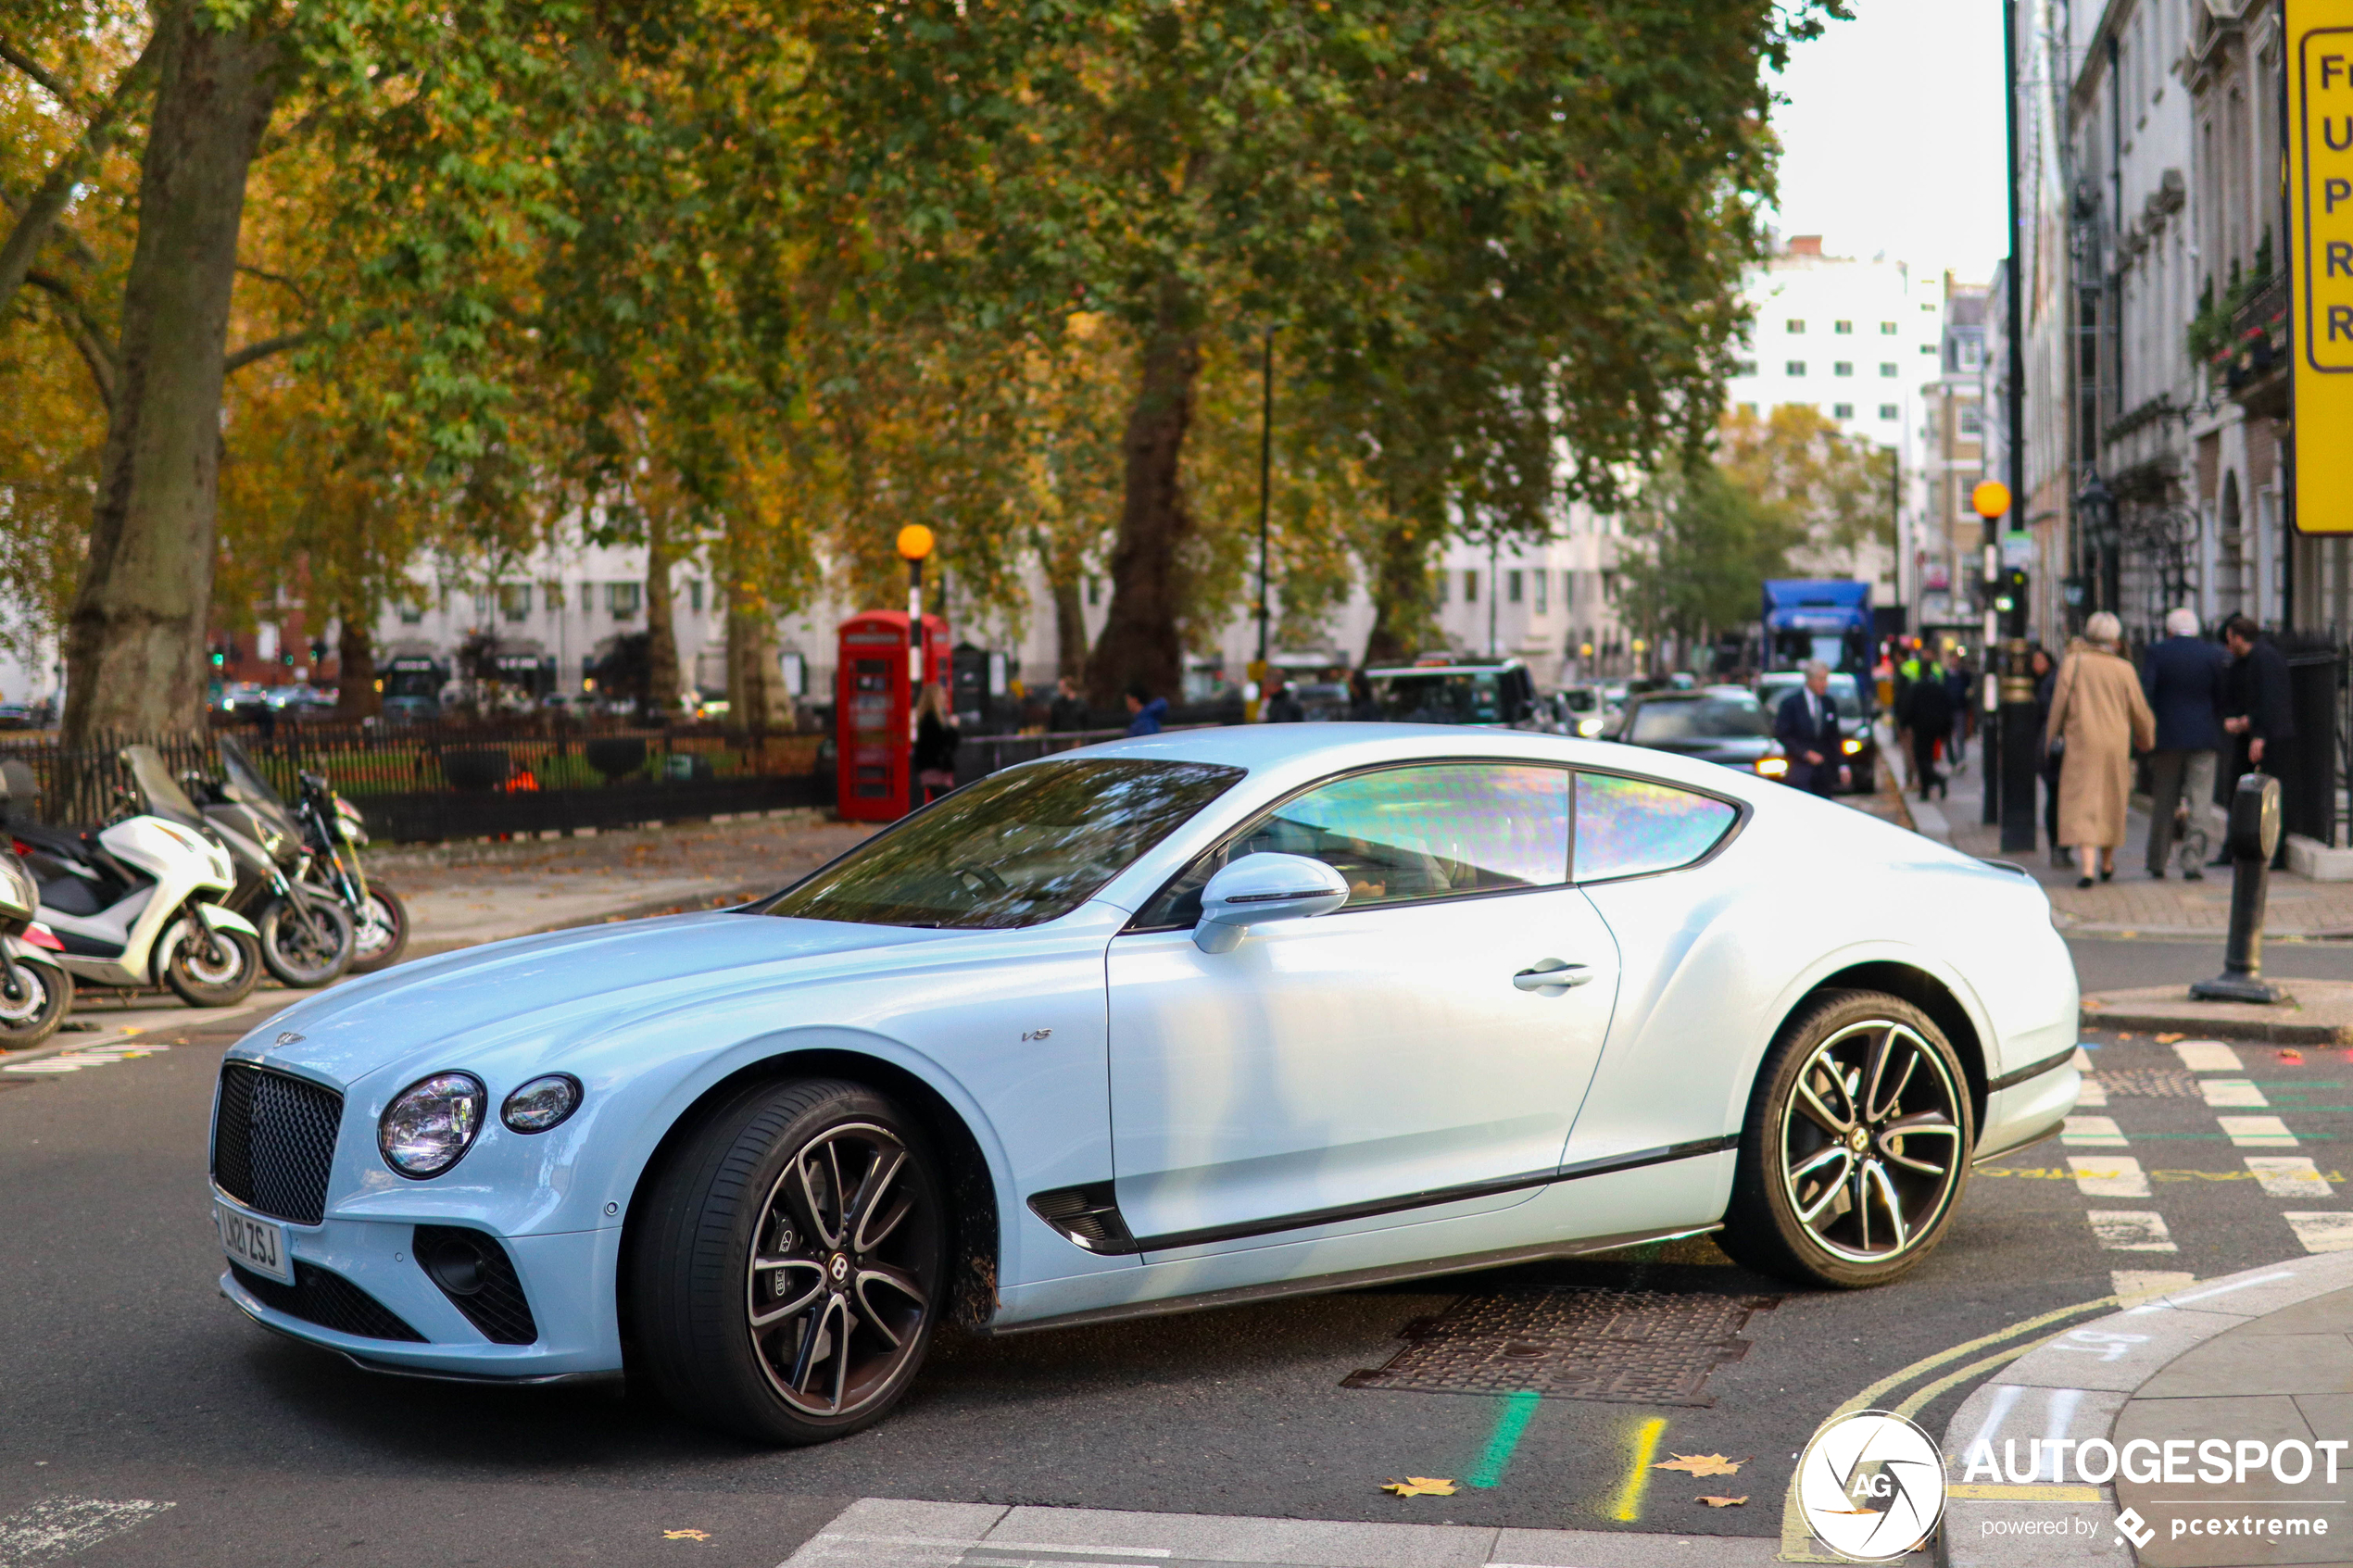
[1106, 761, 1619, 1250]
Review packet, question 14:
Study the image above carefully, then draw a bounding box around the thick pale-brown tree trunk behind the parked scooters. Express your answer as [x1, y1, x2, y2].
[64, 0, 280, 747]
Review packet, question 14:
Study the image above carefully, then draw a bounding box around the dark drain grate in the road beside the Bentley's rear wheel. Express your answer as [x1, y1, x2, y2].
[1341, 1286, 1781, 1406]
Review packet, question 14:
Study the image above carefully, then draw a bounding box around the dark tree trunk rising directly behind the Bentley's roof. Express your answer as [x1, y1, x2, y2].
[1087, 282, 1200, 710]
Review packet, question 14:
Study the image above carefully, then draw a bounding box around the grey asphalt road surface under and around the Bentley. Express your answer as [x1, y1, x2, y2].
[0, 943, 2353, 1568]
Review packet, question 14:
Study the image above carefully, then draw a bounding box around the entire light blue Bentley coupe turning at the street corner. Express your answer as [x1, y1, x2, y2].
[212, 724, 2080, 1443]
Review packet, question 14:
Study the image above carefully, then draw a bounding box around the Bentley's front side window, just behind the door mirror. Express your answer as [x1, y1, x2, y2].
[1137, 761, 1569, 929]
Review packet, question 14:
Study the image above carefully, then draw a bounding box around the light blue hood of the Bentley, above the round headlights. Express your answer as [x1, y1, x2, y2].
[233, 912, 974, 1086]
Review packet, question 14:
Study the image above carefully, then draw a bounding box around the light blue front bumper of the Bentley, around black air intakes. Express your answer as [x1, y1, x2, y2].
[221, 1218, 622, 1382]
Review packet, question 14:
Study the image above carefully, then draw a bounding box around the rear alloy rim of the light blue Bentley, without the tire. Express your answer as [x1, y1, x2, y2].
[1779, 1018, 1967, 1262]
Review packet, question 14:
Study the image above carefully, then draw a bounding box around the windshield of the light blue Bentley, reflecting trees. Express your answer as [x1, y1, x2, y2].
[767, 757, 1242, 931]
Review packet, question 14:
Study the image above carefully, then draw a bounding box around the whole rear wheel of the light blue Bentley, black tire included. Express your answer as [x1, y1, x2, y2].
[1718, 990, 1977, 1290]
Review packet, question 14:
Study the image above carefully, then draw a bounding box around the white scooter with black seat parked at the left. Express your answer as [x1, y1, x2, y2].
[0, 746, 261, 1006]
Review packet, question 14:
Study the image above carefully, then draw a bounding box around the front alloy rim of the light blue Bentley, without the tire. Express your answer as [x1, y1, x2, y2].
[746, 1122, 938, 1418]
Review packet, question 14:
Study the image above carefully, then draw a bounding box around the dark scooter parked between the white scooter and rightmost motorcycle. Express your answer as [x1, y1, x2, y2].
[182, 735, 356, 990]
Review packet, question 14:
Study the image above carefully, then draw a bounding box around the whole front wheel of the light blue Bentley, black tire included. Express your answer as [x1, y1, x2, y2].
[628, 1079, 949, 1443]
